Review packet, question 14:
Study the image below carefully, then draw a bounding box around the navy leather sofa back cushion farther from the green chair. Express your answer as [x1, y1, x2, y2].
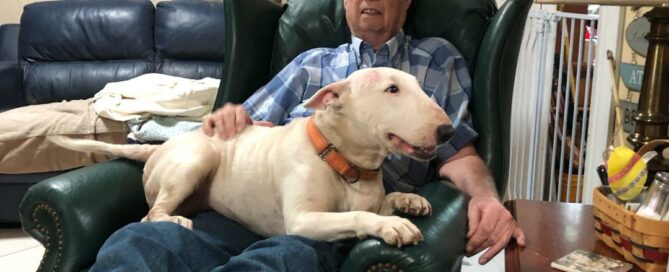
[19, 0, 155, 104]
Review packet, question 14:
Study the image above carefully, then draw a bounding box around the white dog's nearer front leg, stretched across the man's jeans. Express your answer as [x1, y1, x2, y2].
[285, 211, 423, 247]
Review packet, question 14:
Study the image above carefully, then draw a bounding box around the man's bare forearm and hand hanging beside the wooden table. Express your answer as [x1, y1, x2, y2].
[439, 144, 525, 264]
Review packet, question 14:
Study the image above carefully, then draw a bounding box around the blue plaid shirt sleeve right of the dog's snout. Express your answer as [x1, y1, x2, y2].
[434, 43, 478, 161]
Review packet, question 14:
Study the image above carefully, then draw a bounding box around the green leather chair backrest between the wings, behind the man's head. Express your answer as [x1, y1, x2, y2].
[270, 0, 497, 77]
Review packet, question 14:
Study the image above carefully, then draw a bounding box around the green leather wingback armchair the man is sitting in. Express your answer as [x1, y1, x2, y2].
[20, 0, 532, 272]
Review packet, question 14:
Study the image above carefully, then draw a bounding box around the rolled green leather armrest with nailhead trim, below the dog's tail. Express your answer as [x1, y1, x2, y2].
[20, 159, 148, 271]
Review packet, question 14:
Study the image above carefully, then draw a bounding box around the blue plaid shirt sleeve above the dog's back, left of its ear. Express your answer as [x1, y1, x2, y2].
[243, 51, 309, 125]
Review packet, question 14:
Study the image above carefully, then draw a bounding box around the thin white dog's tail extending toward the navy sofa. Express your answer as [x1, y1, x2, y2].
[47, 135, 160, 161]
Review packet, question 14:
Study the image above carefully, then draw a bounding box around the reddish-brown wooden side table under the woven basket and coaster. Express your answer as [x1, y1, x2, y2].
[504, 200, 642, 271]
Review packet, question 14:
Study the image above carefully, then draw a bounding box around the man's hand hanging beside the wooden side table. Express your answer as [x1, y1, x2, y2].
[466, 196, 525, 264]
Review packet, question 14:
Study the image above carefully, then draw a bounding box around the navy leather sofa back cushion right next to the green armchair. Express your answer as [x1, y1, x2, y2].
[155, 1, 225, 79]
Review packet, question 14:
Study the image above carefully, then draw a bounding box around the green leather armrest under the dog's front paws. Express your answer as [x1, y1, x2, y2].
[342, 182, 469, 272]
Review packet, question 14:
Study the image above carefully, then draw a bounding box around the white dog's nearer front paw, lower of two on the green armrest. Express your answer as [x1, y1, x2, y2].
[375, 216, 423, 247]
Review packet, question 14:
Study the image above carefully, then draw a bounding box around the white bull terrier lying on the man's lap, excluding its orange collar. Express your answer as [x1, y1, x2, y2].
[50, 68, 451, 246]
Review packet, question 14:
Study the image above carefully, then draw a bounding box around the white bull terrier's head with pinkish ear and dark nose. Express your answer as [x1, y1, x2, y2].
[305, 68, 453, 160]
